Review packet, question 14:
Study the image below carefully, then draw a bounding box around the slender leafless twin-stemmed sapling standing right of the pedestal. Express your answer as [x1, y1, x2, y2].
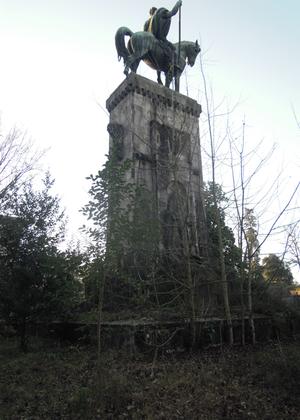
[227, 114, 299, 344]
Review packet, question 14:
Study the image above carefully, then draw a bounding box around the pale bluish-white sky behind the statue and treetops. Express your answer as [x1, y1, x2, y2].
[0, 0, 300, 276]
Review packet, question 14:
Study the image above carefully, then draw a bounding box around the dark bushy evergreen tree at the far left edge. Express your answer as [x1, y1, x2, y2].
[0, 174, 81, 349]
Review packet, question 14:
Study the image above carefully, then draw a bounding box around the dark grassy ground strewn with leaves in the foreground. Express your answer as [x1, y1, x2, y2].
[0, 339, 300, 420]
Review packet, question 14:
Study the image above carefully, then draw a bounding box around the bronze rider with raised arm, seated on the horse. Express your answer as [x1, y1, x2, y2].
[144, 0, 182, 66]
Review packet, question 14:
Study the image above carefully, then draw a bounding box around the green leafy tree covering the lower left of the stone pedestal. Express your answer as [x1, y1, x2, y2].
[82, 149, 159, 310]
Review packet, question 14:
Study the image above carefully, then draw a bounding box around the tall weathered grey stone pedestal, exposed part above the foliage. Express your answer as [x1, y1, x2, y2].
[106, 73, 206, 257]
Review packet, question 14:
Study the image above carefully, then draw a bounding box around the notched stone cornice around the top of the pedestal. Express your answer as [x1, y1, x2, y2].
[106, 73, 201, 117]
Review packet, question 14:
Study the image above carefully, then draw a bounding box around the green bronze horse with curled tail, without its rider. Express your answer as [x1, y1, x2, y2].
[115, 26, 201, 92]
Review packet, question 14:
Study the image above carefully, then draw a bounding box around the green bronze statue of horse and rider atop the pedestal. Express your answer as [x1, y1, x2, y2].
[115, 0, 200, 92]
